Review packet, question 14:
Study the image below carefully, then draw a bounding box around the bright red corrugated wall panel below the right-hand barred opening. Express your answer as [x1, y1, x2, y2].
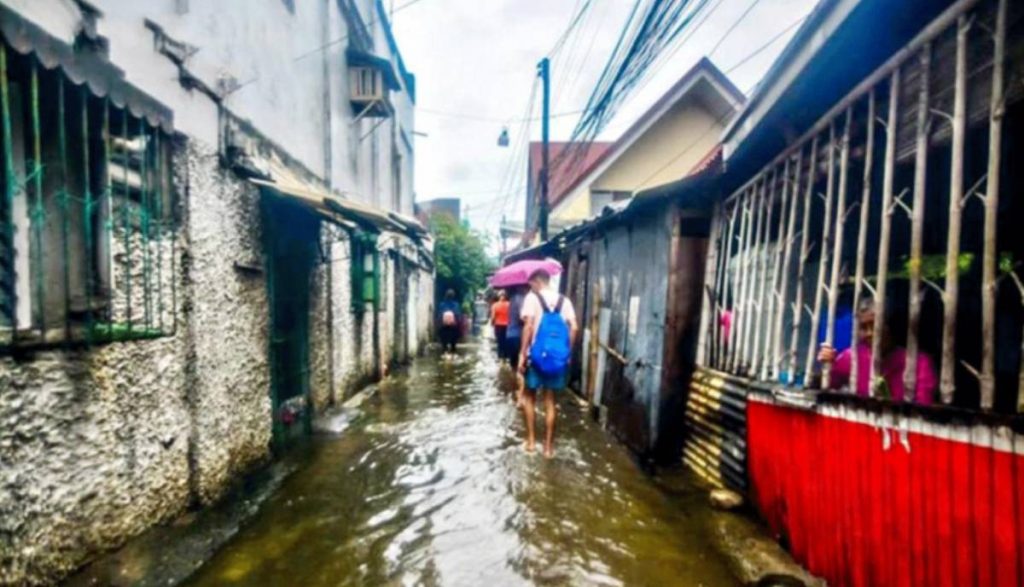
[746, 395, 1024, 587]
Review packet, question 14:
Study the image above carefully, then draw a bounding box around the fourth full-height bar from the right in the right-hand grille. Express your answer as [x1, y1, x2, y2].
[868, 68, 900, 396]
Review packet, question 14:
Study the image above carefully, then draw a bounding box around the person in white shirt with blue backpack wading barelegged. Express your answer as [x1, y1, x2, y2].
[519, 269, 579, 458]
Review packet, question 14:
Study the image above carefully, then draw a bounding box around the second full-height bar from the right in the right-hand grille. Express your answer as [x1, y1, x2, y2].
[939, 14, 970, 404]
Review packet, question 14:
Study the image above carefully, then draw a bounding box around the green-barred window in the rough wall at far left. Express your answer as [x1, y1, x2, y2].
[0, 43, 176, 350]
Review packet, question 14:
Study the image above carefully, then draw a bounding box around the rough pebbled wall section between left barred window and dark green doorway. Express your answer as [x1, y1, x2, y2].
[175, 141, 270, 502]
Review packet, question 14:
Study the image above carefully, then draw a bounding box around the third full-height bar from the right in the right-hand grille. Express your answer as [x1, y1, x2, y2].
[902, 43, 932, 402]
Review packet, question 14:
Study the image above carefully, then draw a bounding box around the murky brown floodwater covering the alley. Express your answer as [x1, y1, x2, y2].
[186, 340, 735, 587]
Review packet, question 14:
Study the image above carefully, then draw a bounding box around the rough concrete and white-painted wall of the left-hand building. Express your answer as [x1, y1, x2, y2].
[0, 0, 423, 584]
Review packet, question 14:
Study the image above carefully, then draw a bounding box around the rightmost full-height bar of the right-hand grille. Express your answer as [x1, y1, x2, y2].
[981, 0, 1007, 410]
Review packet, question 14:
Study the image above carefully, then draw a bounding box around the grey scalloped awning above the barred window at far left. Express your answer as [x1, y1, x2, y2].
[0, 3, 174, 132]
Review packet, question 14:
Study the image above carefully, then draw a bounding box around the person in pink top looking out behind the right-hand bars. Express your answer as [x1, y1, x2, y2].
[818, 298, 938, 406]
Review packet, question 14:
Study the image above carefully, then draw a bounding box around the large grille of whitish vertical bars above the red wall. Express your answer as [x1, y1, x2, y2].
[700, 0, 1024, 410]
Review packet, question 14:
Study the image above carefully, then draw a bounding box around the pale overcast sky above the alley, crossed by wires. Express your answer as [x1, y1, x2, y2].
[385, 0, 816, 238]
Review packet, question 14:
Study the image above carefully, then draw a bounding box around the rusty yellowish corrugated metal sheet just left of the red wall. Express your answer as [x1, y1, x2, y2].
[683, 368, 746, 492]
